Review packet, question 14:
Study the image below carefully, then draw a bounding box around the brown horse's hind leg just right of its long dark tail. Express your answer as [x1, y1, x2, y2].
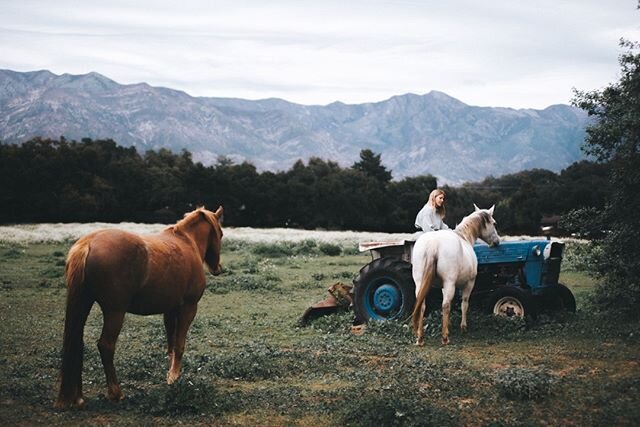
[98, 310, 124, 400]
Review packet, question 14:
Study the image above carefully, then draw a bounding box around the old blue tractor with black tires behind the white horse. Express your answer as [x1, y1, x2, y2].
[352, 239, 576, 324]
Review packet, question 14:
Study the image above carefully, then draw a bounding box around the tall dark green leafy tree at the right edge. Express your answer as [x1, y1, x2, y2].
[573, 40, 640, 318]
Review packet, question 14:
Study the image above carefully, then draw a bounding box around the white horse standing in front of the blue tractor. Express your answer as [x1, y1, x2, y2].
[411, 204, 500, 345]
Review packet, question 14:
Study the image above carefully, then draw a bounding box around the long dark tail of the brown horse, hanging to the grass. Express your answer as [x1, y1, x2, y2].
[55, 235, 94, 408]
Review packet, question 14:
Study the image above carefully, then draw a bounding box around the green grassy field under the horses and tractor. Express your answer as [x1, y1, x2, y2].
[0, 232, 640, 426]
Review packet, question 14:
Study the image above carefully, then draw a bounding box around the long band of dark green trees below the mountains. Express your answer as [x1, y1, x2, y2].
[0, 138, 609, 234]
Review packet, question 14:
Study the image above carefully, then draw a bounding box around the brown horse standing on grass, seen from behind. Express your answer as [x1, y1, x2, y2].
[55, 207, 222, 408]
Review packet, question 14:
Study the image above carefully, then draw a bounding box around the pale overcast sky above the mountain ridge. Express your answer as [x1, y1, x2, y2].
[0, 0, 640, 108]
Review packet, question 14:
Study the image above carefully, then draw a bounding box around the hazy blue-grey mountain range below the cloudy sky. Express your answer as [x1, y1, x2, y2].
[0, 70, 588, 185]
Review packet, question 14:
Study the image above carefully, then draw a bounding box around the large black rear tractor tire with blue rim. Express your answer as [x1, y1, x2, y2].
[353, 257, 416, 323]
